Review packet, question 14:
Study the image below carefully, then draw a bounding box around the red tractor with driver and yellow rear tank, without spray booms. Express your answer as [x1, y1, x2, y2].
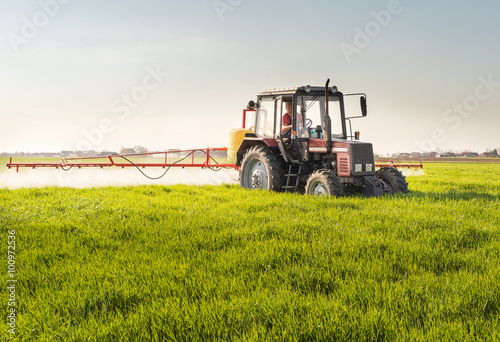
[228, 80, 409, 196]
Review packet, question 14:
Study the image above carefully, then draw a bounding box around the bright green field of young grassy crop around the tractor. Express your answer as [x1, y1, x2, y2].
[0, 164, 500, 341]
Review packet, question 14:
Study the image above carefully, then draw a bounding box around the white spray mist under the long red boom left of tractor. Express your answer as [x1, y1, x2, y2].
[0, 168, 238, 189]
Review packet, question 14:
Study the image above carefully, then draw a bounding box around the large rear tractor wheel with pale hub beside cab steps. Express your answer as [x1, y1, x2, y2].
[240, 145, 285, 191]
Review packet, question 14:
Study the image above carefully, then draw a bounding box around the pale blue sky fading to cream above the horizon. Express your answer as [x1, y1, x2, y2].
[0, 0, 500, 153]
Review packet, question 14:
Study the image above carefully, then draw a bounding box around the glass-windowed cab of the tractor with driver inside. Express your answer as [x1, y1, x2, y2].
[233, 81, 366, 165]
